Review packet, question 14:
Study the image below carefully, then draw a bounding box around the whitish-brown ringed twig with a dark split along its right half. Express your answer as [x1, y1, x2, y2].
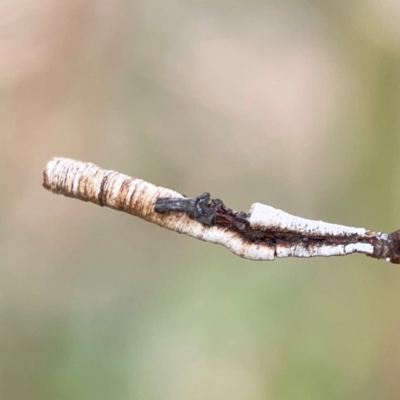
[43, 158, 400, 263]
